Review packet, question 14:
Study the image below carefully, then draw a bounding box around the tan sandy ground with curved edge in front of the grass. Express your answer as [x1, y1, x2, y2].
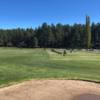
[0, 80, 100, 100]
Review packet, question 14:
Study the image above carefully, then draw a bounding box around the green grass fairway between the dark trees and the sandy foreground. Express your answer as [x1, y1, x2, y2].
[0, 48, 100, 85]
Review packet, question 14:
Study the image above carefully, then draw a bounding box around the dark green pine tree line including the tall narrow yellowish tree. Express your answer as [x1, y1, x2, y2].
[0, 16, 100, 48]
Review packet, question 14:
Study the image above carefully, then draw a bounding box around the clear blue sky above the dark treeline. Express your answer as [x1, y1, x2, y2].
[0, 0, 100, 28]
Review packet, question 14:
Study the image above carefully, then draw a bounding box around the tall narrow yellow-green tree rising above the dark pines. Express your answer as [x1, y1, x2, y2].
[86, 16, 91, 49]
